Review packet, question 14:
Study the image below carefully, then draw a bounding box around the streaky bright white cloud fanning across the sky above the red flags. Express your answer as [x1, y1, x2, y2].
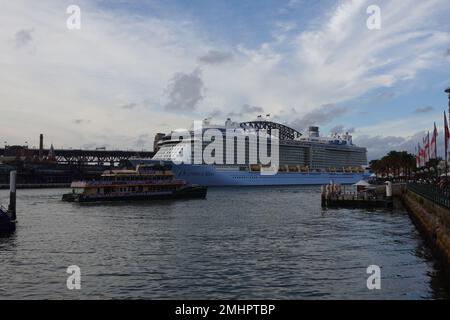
[282, 0, 450, 112]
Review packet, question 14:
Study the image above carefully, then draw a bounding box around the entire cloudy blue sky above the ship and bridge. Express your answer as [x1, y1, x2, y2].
[0, 0, 450, 159]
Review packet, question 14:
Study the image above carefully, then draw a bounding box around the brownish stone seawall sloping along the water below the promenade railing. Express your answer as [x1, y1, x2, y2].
[401, 190, 450, 276]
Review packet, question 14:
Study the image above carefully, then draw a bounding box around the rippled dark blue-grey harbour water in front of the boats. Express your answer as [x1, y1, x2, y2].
[0, 187, 450, 299]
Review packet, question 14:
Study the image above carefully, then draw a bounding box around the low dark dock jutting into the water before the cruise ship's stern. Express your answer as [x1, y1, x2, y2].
[321, 182, 393, 208]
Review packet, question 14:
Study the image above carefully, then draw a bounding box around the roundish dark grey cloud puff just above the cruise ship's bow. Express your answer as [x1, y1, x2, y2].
[164, 68, 205, 112]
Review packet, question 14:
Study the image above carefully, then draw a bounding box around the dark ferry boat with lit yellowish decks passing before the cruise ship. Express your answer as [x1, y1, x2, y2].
[62, 163, 207, 202]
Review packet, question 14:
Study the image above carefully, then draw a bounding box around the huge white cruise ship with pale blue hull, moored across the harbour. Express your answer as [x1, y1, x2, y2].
[149, 117, 367, 186]
